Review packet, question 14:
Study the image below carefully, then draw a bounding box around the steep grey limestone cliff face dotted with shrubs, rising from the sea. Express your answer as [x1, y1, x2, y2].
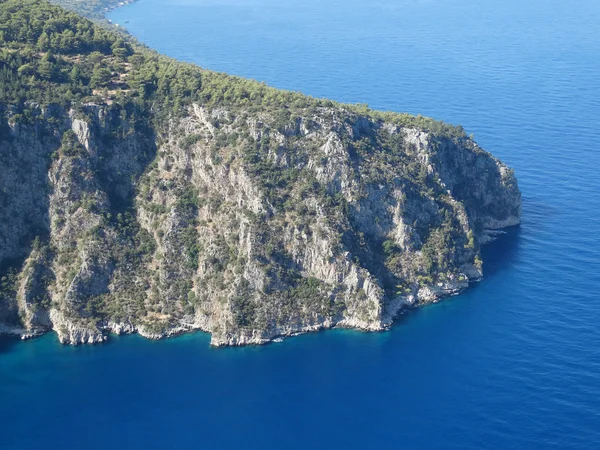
[0, 104, 521, 346]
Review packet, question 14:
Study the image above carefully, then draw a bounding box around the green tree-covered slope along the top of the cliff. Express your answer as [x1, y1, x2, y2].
[0, 0, 465, 139]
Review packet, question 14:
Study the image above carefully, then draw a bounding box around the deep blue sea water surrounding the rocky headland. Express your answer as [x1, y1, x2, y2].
[0, 0, 600, 450]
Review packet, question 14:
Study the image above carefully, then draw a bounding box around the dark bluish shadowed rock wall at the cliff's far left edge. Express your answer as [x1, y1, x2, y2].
[0, 106, 60, 325]
